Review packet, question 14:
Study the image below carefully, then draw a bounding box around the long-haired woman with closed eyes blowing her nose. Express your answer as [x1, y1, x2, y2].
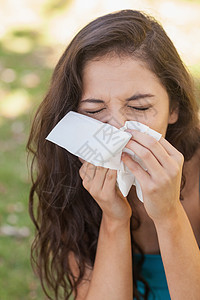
[28, 10, 200, 300]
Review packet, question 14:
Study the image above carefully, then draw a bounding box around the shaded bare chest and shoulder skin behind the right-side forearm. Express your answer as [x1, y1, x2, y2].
[128, 146, 200, 254]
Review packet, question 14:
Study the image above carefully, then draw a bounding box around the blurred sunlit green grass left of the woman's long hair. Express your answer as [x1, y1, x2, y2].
[0, 26, 52, 300]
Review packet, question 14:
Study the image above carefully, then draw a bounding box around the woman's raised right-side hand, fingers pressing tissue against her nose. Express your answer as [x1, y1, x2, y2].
[122, 130, 184, 221]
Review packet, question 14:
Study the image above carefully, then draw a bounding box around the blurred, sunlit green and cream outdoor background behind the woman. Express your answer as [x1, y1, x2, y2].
[0, 0, 200, 300]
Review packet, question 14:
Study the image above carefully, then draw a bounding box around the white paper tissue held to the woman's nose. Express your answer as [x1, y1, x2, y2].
[46, 111, 162, 202]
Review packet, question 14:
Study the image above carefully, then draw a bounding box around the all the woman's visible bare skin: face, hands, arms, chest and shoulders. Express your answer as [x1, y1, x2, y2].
[71, 56, 200, 300]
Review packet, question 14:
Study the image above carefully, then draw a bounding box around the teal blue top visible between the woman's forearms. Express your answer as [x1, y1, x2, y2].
[133, 177, 200, 300]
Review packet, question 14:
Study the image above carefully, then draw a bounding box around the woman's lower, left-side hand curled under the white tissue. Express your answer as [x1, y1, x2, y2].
[79, 161, 132, 223]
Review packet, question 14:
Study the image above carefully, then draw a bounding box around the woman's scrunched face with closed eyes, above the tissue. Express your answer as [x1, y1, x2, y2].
[78, 55, 178, 137]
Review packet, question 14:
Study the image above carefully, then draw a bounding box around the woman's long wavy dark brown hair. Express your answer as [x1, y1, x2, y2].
[27, 10, 200, 300]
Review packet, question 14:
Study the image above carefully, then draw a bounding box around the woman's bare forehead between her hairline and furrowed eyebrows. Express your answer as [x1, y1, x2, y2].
[83, 55, 166, 95]
